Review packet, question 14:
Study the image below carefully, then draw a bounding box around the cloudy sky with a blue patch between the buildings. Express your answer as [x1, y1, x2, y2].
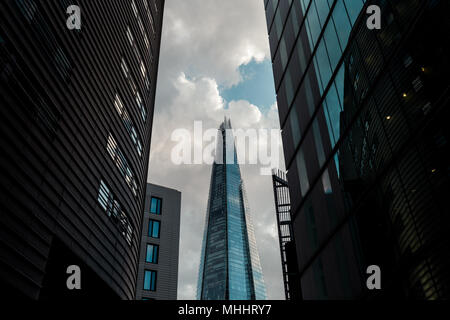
[148, 0, 284, 299]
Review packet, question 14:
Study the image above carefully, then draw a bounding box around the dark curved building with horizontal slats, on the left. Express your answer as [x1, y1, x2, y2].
[0, 0, 164, 299]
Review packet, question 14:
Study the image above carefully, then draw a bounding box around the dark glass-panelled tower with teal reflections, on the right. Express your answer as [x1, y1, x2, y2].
[265, 0, 450, 299]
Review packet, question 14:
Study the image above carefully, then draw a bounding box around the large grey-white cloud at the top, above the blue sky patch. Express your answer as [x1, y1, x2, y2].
[162, 0, 270, 89]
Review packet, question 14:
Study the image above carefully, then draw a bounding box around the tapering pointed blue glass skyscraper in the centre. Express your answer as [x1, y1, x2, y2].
[197, 119, 266, 300]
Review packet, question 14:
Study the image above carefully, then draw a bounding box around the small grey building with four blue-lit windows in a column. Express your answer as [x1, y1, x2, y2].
[136, 183, 181, 300]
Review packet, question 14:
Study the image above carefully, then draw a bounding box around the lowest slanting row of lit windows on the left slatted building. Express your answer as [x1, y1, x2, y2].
[97, 180, 133, 246]
